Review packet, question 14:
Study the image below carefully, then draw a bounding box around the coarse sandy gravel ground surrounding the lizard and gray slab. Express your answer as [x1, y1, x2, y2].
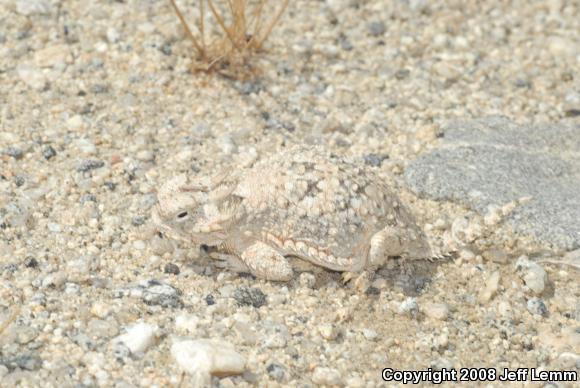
[0, 0, 580, 387]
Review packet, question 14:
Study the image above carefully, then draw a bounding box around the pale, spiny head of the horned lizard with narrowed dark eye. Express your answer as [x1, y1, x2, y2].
[152, 175, 227, 246]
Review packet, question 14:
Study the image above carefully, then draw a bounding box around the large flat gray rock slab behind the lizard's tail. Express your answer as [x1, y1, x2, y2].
[405, 117, 580, 250]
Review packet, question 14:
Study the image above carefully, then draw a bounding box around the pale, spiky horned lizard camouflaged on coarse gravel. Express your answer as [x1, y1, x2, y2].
[153, 146, 432, 287]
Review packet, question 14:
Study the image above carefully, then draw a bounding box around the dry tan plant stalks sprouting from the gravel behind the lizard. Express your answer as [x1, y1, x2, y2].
[169, 0, 289, 75]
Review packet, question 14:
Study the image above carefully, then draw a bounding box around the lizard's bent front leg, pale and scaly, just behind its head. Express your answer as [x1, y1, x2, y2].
[240, 241, 293, 281]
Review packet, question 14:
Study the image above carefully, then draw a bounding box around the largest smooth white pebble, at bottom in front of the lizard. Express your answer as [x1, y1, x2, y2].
[171, 339, 246, 386]
